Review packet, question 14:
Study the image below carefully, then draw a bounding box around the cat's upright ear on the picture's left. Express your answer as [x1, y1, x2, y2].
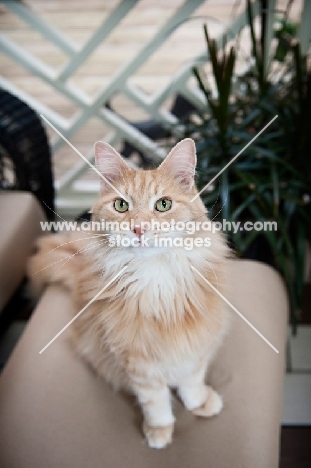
[94, 141, 128, 191]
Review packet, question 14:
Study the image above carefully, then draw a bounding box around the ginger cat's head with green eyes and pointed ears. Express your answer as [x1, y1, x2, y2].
[92, 139, 206, 254]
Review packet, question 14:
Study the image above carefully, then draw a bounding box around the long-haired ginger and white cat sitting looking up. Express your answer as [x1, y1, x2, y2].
[29, 139, 229, 448]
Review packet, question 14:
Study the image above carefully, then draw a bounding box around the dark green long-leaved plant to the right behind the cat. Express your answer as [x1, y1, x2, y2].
[185, 1, 311, 325]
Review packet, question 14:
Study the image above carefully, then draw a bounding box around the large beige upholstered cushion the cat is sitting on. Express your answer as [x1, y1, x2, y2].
[0, 261, 287, 468]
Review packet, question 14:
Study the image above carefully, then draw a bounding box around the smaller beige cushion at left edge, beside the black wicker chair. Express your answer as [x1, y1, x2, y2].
[0, 191, 45, 311]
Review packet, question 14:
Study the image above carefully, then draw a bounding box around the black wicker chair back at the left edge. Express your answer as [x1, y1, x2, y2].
[0, 89, 54, 219]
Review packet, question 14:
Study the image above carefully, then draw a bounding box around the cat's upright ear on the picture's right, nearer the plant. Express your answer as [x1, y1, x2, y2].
[160, 138, 197, 189]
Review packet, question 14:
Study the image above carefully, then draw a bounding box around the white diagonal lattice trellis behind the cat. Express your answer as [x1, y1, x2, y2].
[0, 0, 311, 215]
